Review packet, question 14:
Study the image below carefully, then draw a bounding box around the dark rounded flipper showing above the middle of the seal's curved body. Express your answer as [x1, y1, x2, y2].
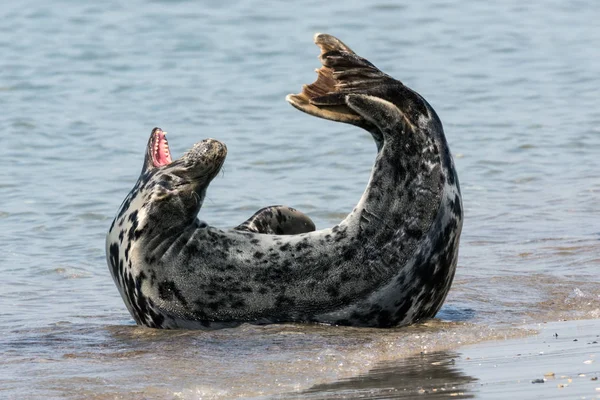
[234, 206, 315, 235]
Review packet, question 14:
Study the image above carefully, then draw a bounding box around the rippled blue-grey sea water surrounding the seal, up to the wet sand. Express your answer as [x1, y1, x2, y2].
[0, 0, 600, 398]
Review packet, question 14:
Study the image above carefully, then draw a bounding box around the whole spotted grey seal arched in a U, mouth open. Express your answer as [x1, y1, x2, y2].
[106, 34, 462, 328]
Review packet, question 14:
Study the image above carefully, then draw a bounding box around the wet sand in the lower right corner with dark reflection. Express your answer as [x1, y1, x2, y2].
[300, 320, 600, 399]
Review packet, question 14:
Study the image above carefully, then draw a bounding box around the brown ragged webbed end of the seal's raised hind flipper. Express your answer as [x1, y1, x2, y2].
[286, 33, 361, 124]
